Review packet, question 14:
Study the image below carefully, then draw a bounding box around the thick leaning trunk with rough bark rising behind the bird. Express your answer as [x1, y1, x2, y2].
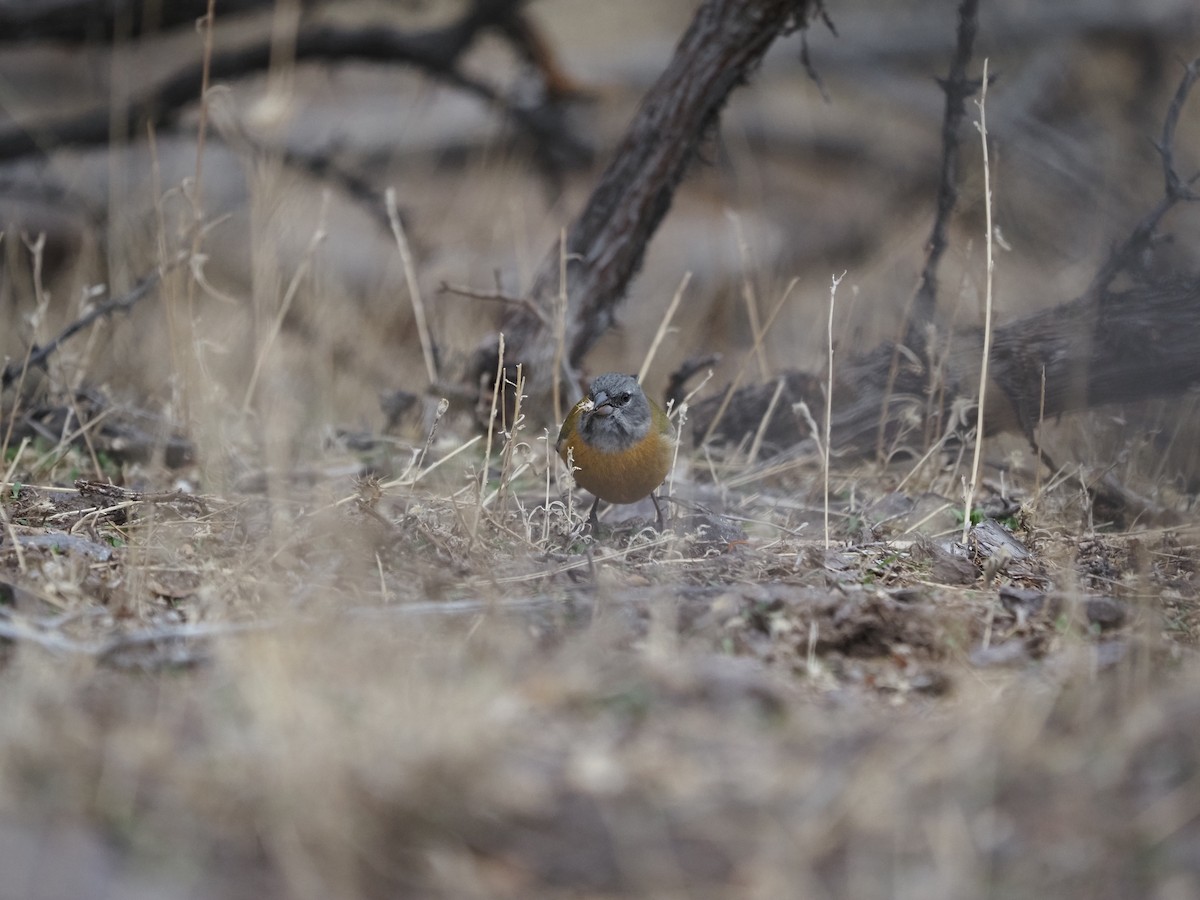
[472, 0, 822, 409]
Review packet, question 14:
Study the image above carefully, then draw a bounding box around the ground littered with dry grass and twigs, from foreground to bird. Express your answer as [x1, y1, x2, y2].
[0, 398, 1200, 898]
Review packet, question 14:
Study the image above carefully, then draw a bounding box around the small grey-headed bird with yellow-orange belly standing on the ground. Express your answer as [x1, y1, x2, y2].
[554, 372, 674, 532]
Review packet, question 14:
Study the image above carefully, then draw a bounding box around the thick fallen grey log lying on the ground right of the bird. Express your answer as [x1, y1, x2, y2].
[692, 280, 1200, 456]
